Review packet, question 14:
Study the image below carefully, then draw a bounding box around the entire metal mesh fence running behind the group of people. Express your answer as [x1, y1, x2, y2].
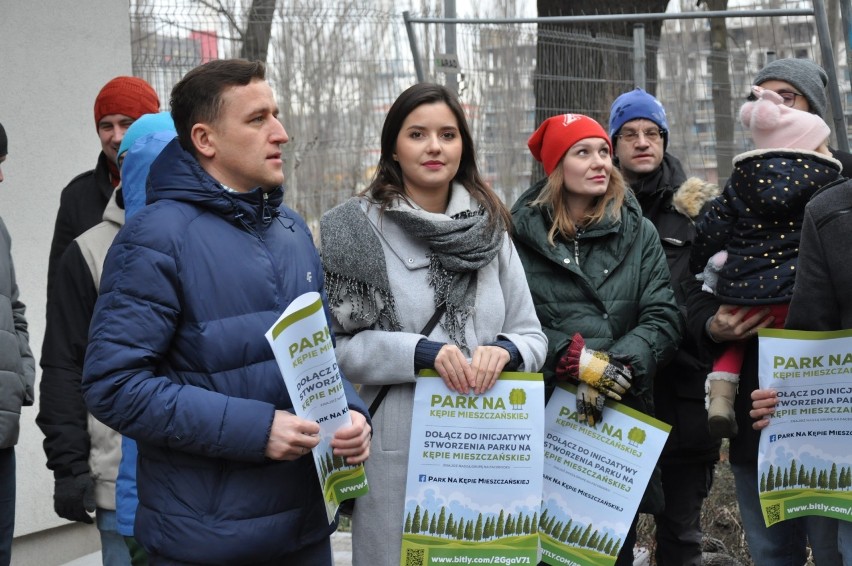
[130, 0, 849, 221]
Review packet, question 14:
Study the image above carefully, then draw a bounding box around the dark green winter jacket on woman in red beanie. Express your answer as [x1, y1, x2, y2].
[512, 181, 683, 415]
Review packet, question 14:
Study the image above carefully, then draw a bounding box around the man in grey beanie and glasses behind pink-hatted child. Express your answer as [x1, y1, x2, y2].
[744, 58, 852, 174]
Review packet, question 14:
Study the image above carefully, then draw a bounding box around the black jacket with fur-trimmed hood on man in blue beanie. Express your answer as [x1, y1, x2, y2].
[632, 154, 720, 464]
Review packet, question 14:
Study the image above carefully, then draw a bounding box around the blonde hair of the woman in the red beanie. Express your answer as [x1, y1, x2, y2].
[530, 162, 626, 246]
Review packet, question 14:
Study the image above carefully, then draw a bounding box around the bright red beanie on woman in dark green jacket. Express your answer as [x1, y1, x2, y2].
[527, 114, 612, 175]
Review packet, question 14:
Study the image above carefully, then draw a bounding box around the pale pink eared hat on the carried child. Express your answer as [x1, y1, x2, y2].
[740, 86, 831, 151]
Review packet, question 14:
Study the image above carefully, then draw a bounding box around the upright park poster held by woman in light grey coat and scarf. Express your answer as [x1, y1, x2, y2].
[400, 371, 544, 566]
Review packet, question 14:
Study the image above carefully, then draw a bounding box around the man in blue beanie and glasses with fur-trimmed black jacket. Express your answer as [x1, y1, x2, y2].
[609, 88, 720, 566]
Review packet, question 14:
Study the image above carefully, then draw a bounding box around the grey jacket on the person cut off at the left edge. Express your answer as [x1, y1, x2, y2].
[0, 220, 35, 448]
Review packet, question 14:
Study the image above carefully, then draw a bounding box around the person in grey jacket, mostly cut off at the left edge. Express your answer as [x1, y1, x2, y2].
[0, 124, 35, 566]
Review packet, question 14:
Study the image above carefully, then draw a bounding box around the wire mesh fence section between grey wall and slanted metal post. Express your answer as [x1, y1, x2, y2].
[131, 0, 415, 226]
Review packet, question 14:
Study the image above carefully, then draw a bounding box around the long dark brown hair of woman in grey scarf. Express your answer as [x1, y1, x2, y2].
[361, 83, 512, 230]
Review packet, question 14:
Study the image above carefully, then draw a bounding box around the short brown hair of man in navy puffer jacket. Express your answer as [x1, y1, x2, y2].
[169, 59, 266, 155]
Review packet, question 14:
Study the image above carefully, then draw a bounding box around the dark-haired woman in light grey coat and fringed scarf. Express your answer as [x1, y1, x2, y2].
[320, 84, 547, 566]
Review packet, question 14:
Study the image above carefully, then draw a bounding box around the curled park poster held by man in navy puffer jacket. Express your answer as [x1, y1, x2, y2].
[266, 292, 369, 522]
